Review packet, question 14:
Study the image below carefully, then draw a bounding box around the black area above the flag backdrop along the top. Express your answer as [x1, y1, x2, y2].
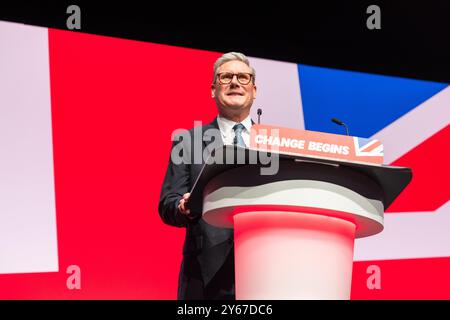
[0, 1, 450, 83]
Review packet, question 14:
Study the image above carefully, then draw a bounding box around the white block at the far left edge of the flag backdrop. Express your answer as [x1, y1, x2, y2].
[0, 21, 58, 273]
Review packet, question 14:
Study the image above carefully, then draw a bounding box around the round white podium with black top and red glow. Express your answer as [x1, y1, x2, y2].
[190, 146, 412, 300]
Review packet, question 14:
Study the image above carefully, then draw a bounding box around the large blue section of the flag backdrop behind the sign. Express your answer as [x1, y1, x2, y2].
[298, 65, 447, 137]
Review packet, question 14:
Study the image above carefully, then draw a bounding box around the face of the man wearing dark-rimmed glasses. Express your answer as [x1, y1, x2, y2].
[211, 61, 256, 115]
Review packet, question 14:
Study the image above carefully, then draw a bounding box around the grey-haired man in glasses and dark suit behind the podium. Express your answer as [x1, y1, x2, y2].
[159, 52, 256, 299]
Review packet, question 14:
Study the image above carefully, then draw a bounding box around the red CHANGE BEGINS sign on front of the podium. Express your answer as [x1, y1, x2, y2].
[250, 125, 383, 165]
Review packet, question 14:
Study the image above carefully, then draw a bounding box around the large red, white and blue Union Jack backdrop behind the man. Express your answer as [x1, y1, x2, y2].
[0, 22, 450, 299]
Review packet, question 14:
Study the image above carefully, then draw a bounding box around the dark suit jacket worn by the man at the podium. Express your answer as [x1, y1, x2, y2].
[158, 118, 234, 299]
